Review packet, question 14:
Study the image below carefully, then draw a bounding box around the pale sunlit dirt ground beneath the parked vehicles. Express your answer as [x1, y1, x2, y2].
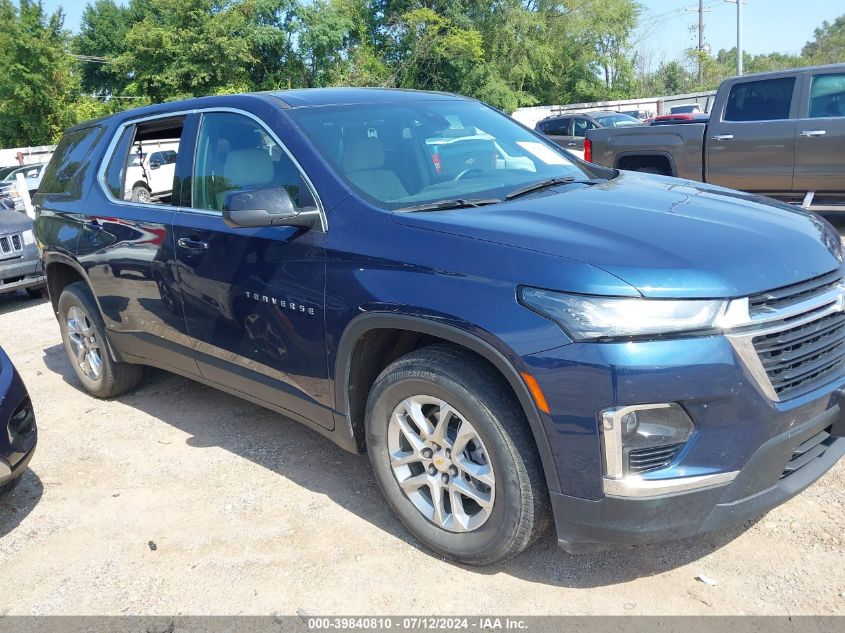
[0, 294, 845, 615]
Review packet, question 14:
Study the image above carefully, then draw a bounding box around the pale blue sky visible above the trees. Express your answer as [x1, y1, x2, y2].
[44, 0, 845, 66]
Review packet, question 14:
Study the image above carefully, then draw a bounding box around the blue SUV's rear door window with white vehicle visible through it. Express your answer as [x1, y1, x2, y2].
[105, 117, 185, 204]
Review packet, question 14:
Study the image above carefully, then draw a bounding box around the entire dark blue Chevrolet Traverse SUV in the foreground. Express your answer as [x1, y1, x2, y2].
[35, 89, 845, 564]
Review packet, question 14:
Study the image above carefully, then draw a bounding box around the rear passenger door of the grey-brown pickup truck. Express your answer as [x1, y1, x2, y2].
[705, 74, 801, 193]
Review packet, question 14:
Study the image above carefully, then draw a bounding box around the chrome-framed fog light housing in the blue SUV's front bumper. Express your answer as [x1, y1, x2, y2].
[600, 403, 695, 479]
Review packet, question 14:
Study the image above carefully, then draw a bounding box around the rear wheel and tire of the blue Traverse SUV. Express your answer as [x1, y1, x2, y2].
[58, 281, 143, 398]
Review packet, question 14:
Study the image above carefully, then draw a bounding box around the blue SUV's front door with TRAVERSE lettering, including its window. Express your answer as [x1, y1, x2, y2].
[174, 112, 334, 429]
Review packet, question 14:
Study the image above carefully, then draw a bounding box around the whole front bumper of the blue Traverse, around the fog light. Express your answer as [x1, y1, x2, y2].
[523, 336, 845, 552]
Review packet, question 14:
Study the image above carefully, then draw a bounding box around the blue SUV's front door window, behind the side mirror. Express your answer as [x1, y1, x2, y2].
[191, 112, 314, 212]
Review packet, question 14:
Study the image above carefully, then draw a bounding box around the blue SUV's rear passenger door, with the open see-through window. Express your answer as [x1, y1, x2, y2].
[77, 115, 197, 374]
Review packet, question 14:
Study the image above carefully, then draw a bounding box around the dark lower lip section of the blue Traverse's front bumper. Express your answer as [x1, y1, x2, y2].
[552, 399, 845, 553]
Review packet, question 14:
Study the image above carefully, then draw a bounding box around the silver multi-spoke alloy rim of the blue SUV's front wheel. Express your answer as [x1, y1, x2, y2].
[387, 395, 496, 532]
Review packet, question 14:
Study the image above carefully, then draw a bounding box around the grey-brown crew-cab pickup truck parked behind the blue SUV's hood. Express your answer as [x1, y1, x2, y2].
[585, 64, 845, 211]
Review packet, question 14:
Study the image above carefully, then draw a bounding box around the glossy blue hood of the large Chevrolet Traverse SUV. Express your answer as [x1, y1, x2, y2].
[394, 172, 842, 298]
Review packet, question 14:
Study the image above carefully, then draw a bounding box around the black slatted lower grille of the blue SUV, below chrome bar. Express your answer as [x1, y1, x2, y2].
[753, 312, 845, 400]
